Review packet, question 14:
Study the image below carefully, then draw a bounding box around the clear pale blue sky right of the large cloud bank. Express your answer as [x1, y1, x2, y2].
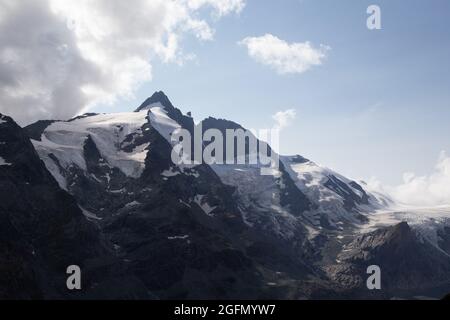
[95, 0, 450, 184]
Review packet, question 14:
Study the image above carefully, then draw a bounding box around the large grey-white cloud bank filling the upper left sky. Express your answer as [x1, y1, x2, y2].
[0, 0, 245, 124]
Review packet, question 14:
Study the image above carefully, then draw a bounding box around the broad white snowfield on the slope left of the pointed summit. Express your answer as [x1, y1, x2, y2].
[32, 111, 148, 182]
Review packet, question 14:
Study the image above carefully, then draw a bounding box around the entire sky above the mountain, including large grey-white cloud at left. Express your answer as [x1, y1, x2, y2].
[0, 0, 450, 184]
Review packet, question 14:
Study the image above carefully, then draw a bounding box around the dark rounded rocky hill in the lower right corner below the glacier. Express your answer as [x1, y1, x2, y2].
[329, 222, 450, 297]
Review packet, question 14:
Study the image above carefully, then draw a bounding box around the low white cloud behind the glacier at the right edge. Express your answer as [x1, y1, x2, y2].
[371, 151, 450, 207]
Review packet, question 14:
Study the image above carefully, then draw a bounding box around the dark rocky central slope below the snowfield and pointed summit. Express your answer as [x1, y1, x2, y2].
[16, 100, 315, 299]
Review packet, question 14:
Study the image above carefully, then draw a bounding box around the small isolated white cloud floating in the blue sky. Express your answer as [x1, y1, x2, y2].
[239, 34, 330, 74]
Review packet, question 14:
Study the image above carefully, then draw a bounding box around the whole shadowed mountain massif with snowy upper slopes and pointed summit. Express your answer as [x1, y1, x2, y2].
[0, 92, 450, 299]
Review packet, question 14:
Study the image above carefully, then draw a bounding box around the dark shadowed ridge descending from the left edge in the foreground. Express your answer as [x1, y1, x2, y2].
[0, 116, 137, 299]
